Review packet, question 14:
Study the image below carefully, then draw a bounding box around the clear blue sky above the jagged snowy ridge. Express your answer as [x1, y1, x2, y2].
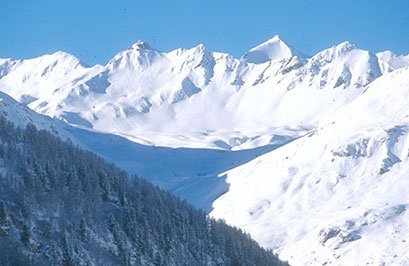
[0, 0, 409, 64]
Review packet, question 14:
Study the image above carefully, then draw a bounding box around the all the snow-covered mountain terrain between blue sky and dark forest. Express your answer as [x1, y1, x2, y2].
[0, 36, 409, 265]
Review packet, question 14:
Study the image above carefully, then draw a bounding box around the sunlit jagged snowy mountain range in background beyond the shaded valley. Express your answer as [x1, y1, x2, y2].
[0, 36, 405, 149]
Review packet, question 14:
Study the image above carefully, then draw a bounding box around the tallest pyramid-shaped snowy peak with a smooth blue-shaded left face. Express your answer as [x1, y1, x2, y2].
[242, 35, 303, 64]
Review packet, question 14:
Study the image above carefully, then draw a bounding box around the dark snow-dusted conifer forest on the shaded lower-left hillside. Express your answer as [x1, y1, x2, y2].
[0, 116, 287, 265]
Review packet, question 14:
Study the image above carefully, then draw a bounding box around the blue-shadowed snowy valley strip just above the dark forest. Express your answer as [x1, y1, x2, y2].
[0, 92, 293, 212]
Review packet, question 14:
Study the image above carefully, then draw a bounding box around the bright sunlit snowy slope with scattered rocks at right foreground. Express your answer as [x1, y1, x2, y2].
[211, 68, 409, 265]
